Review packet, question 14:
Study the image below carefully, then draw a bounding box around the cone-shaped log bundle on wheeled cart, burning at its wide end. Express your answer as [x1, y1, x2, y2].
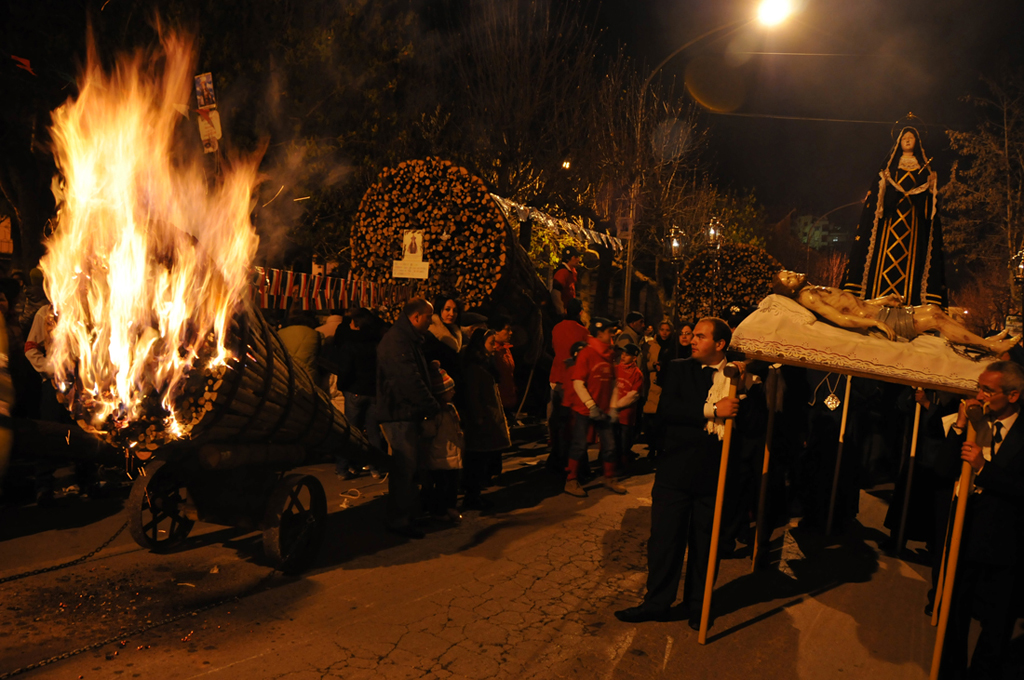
[61, 305, 384, 467]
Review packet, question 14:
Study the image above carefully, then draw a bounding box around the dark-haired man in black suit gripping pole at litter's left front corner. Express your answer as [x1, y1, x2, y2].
[615, 317, 739, 630]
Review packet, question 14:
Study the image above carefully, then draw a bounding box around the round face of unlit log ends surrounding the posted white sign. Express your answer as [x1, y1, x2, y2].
[351, 158, 512, 307]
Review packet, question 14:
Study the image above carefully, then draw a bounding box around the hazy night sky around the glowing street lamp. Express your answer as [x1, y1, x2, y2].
[599, 0, 1024, 225]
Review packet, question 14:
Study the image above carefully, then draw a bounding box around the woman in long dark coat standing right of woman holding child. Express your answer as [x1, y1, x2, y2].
[456, 329, 512, 510]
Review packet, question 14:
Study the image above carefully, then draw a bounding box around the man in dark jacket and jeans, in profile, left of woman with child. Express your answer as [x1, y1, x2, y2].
[377, 298, 441, 539]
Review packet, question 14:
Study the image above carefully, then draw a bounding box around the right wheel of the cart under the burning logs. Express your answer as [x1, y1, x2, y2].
[263, 474, 327, 573]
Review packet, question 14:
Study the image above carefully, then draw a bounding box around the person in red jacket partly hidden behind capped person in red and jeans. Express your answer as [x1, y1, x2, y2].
[547, 298, 590, 474]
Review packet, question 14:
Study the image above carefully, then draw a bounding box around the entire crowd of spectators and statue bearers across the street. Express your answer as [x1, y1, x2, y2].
[0, 248, 1024, 677]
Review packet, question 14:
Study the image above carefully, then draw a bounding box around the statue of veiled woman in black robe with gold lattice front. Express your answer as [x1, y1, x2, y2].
[842, 127, 947, 307]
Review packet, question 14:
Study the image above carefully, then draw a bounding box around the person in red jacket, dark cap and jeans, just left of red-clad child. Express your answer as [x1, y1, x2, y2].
[565, 317, 626, 497]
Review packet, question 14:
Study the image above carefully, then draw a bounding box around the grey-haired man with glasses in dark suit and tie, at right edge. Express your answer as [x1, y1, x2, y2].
[937, 362, 1024, 680]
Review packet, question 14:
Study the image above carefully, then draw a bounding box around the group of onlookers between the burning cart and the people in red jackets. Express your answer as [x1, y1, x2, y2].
[294, 294, 517, 538]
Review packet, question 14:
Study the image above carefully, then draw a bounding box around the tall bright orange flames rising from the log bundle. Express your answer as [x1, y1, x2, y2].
[40, 34, 259, 438]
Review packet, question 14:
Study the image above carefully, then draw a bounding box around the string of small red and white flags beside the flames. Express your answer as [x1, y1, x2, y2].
[251, 267, 416, 311]
